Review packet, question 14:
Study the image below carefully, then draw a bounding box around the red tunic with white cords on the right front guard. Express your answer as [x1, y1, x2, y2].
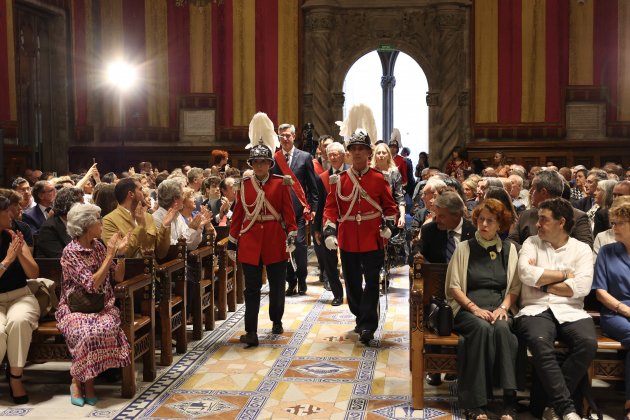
[323, 168, 398, 252]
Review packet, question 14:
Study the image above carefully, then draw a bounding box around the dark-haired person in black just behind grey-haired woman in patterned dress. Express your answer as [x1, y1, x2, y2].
[35, 187, 83, 258]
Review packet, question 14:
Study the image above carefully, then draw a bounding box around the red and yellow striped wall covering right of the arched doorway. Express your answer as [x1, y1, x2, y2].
[473, 0, 630, 126]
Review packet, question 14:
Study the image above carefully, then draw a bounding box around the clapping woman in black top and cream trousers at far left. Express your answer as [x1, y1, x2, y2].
[0, 195, 39, 404]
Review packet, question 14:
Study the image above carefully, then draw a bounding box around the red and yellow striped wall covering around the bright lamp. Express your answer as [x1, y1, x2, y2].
[66, 0, 300, 128]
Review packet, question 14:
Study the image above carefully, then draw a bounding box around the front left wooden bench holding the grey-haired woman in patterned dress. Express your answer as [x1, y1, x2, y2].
[28, 258, 156, 398]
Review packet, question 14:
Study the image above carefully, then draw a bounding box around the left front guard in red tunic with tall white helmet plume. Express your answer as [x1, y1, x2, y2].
[228, 113, 297, 347]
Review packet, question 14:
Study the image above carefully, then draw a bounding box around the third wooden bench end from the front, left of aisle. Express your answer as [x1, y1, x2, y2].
[187, 231, 216, 340]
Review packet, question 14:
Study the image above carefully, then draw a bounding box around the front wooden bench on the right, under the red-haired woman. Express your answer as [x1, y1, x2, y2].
[409, 255, 626, 410]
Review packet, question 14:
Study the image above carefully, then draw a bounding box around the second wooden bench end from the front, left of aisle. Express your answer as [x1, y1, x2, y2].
[154, 238, 188, 366]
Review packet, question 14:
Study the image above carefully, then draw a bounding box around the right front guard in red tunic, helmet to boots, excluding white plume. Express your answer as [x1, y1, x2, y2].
[323, 129, 398, 346]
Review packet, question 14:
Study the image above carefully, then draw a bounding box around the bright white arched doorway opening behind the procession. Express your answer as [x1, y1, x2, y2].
[343, 50, 429, 165]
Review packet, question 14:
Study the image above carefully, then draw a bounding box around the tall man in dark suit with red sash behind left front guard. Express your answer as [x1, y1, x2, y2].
[273, 124, 318, 296]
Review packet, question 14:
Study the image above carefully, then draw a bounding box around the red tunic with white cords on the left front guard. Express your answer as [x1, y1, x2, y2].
[230, 174, 297, 265]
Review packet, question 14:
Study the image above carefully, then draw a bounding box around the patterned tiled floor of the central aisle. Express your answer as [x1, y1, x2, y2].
[0, 260, 623, 420]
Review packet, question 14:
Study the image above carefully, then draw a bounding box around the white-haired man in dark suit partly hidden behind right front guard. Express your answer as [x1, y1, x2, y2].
[313, 142, 350, 306]
